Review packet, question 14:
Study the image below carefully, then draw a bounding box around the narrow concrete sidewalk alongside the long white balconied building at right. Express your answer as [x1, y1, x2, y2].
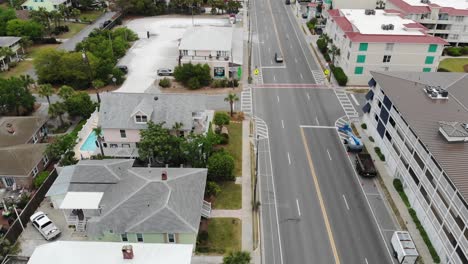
[356, 124, 433, 263]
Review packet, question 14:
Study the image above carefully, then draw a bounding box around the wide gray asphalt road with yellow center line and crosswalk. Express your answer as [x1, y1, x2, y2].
[251, 0, 395, 264]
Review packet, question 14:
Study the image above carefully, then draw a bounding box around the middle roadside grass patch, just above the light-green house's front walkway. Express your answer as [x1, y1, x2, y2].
[213, 182, 242, 210]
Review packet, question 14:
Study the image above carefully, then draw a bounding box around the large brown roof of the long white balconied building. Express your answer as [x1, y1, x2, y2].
[371, 71, 468, 201]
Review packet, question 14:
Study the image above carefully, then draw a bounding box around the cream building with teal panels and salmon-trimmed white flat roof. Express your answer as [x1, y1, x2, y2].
[324, 9, 448, 85]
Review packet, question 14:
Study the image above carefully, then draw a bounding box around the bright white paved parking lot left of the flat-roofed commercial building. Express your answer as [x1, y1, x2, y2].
[117, 16, 229, 93]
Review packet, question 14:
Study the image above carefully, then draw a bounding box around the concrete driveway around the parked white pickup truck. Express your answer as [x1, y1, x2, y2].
[18, 198, 86, 256]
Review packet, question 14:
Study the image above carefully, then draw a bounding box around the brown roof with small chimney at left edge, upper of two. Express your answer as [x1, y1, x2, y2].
[0, 116, 46, 147]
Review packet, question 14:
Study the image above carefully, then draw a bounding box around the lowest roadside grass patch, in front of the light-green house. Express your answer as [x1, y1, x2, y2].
[197, 218, 242, 254]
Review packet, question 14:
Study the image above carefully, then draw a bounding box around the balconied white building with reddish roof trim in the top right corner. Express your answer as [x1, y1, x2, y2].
[386, 0, 468, 45]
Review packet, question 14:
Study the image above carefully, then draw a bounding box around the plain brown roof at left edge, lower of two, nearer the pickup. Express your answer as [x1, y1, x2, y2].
[0, 144, 47, 177]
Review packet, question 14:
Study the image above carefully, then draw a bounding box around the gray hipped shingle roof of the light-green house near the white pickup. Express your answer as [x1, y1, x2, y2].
[51, 159, 207, 236]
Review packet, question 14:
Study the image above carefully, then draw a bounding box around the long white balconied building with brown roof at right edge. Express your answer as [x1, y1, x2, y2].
[363, 72, 468, 264]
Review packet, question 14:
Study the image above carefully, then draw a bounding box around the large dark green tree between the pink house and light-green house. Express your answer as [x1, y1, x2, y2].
[138, 122, 185, 165]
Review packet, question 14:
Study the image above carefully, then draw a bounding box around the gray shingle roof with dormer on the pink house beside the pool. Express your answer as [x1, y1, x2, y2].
[99, 93, 206, 130]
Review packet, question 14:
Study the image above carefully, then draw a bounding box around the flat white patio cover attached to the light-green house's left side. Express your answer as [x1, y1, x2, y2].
[60, 192, 104, 209]
